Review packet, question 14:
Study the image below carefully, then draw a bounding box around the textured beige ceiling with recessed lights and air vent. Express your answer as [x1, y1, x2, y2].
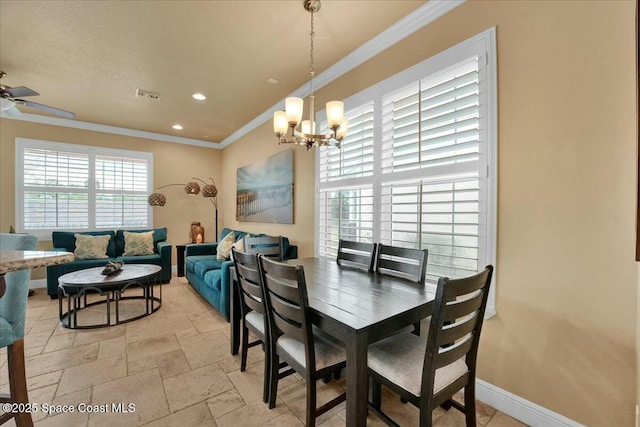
[0, 0, 425, 142]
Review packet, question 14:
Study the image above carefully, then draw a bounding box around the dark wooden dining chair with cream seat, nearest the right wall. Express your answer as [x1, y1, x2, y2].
[368, 265, 493, 427]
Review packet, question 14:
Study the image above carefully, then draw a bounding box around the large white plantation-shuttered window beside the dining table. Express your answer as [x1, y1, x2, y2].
[316, 29, 497, 311]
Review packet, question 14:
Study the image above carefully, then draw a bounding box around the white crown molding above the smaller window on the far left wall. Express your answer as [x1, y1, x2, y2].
[0, 111, 222, 150]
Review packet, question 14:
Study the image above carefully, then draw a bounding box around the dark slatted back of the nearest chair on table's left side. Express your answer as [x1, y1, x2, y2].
[258, 254, 316, 372]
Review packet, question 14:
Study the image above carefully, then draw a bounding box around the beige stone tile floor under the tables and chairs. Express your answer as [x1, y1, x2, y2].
[0, 277, 523, 427]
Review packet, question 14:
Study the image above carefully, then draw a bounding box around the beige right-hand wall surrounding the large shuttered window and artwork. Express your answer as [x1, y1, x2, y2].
[223, 0, 638, 426]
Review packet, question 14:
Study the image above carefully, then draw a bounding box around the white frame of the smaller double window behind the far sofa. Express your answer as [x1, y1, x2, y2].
[15, 138, 153, 240]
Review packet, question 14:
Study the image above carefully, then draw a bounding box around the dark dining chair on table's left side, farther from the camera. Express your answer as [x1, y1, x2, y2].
[231, 248, 269, 403]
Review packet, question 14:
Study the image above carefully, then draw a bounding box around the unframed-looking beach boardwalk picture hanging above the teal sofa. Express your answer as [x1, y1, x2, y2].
[236, 149, 293, 224]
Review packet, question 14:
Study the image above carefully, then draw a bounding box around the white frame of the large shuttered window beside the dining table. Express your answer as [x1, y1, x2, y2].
[314, 27, 498, 317]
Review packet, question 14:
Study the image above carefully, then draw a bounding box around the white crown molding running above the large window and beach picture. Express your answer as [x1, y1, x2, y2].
[220, 0, 466, 148]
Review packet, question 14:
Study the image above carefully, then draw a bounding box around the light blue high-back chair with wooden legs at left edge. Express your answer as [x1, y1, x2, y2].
[0, 233, 38, 427]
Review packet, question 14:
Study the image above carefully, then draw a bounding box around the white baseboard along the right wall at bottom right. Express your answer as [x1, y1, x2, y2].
[476, 379, 582, 427]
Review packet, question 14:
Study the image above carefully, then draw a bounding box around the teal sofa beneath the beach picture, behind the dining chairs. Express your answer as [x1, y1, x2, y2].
[185, 228, 298, 320]
